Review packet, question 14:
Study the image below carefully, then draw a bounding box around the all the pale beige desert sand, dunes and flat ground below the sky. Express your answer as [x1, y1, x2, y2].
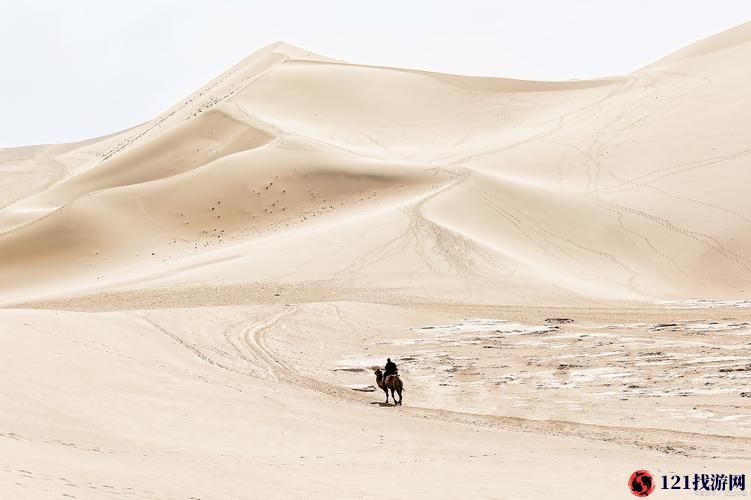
[0, 24, 751, 499]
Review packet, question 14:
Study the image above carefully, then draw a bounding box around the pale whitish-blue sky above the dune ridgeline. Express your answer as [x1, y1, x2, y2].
[0, 0, 751, 146]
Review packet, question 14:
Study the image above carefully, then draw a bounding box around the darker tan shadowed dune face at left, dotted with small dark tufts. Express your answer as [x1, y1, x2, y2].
[0, 135, 446, 297]
